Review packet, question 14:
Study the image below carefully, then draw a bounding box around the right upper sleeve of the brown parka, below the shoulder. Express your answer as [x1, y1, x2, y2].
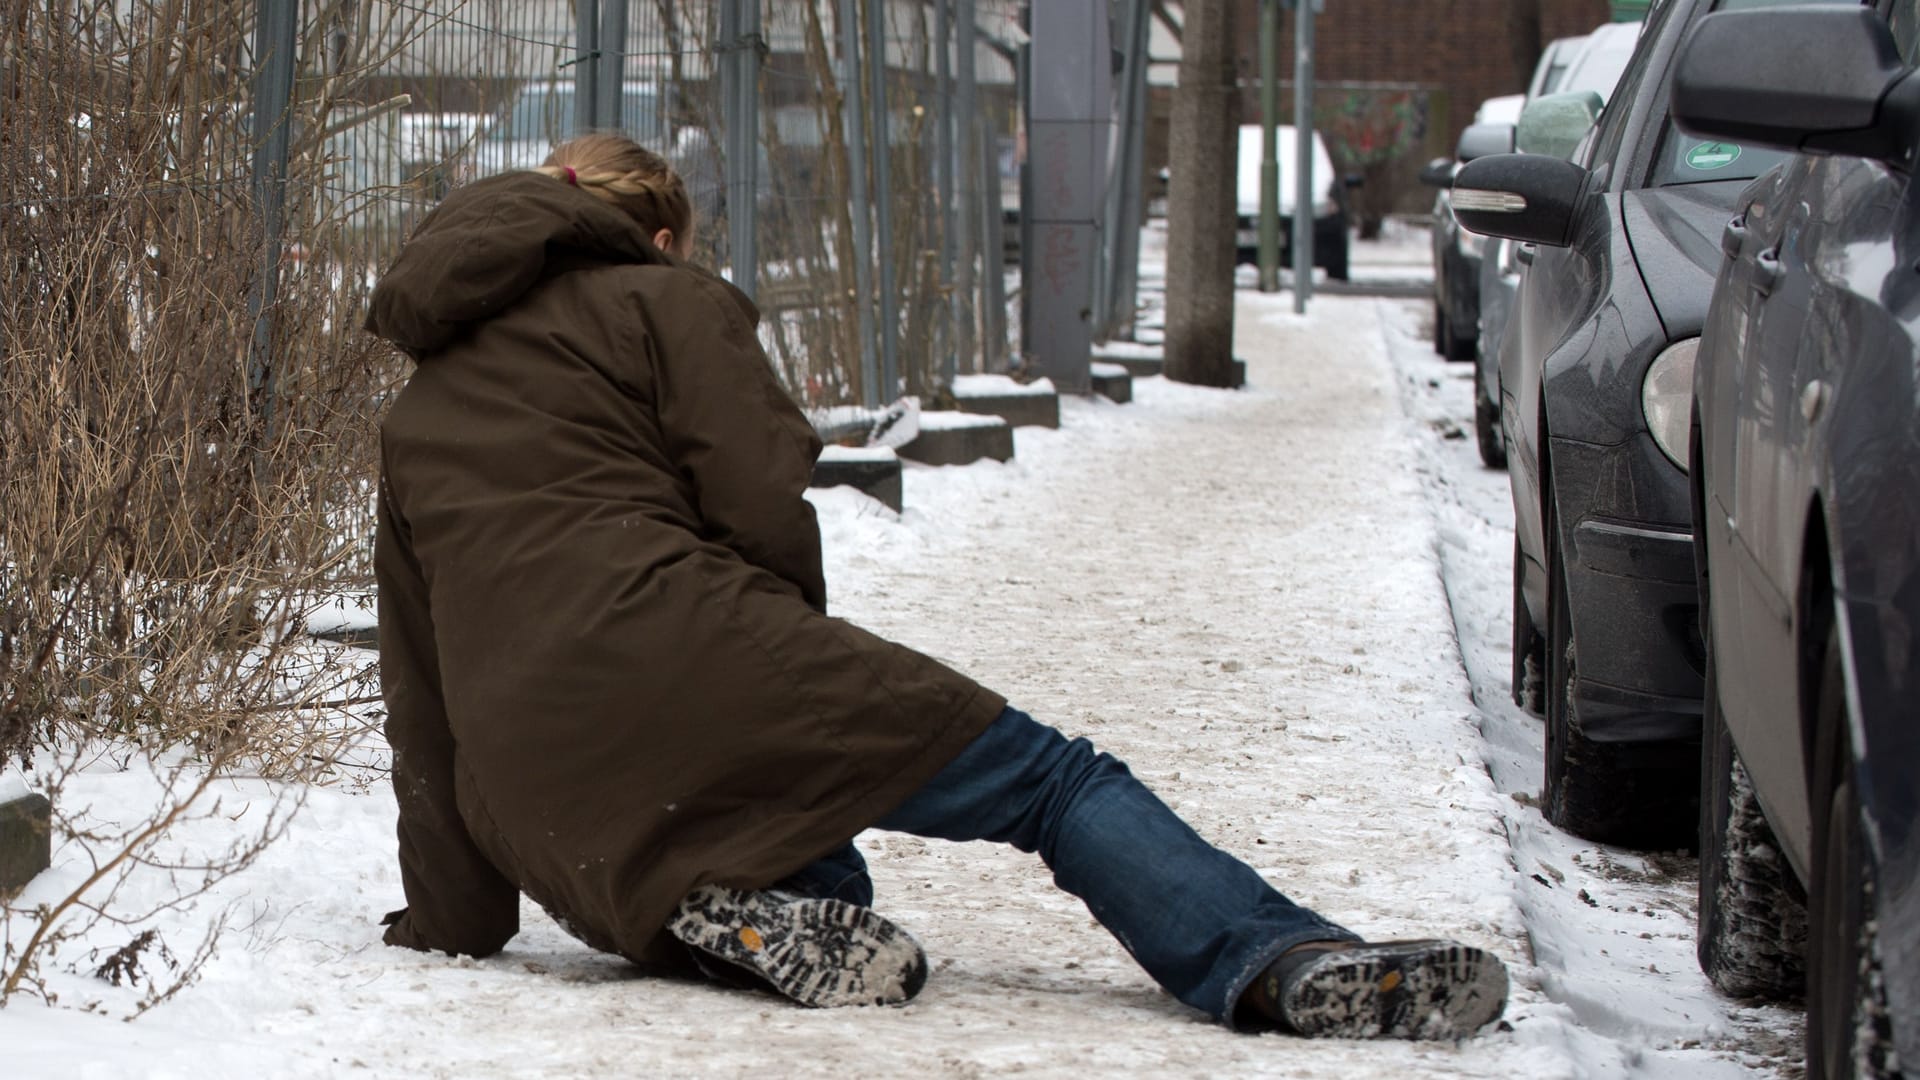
[649, 273, 828, 613]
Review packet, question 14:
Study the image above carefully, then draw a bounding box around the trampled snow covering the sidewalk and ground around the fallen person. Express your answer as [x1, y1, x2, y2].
[0, 229, 1799, 1080]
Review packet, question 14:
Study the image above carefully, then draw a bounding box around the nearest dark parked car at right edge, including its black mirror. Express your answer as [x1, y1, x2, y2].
[1672, 0, 1920, 1080]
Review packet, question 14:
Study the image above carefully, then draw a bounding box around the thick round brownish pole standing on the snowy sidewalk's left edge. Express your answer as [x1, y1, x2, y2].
[1165, 0, 1240, 386]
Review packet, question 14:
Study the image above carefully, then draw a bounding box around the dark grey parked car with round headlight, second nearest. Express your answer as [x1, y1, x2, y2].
[1453, 0, 1812, 846]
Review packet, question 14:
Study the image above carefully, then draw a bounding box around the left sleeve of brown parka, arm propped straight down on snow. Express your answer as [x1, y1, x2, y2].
[374, 474, 520, 957]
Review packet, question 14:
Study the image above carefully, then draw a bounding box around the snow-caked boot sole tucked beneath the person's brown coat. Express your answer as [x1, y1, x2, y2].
[666, 886, 927, 1009]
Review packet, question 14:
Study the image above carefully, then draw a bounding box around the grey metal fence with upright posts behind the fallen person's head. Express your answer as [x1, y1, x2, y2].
[266, 0, 1018, 407]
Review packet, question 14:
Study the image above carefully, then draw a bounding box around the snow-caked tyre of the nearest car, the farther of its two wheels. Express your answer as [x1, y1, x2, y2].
[1693, 634, 1807, 1001]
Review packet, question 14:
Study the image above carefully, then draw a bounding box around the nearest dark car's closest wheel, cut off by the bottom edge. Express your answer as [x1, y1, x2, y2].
[1807, 628, 1899, 1080]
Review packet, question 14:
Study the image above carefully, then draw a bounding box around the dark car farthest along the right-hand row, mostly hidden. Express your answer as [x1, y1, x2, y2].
[1421, 94, 1526, 359]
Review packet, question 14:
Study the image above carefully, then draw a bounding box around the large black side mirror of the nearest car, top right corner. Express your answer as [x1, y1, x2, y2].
[1672, 6, 1920, 161]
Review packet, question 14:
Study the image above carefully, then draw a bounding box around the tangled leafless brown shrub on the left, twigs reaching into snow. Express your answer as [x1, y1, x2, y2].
[0, 0, 399, 1009]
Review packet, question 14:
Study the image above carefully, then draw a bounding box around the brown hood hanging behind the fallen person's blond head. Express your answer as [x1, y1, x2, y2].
[367, 173, 680, 359]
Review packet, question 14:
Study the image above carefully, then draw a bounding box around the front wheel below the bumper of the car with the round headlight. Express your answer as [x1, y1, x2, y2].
[1542, 507, 1699, 847]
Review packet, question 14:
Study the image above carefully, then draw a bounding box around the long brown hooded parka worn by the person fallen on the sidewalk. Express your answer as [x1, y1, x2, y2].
[367, 173, 1006, 963]
